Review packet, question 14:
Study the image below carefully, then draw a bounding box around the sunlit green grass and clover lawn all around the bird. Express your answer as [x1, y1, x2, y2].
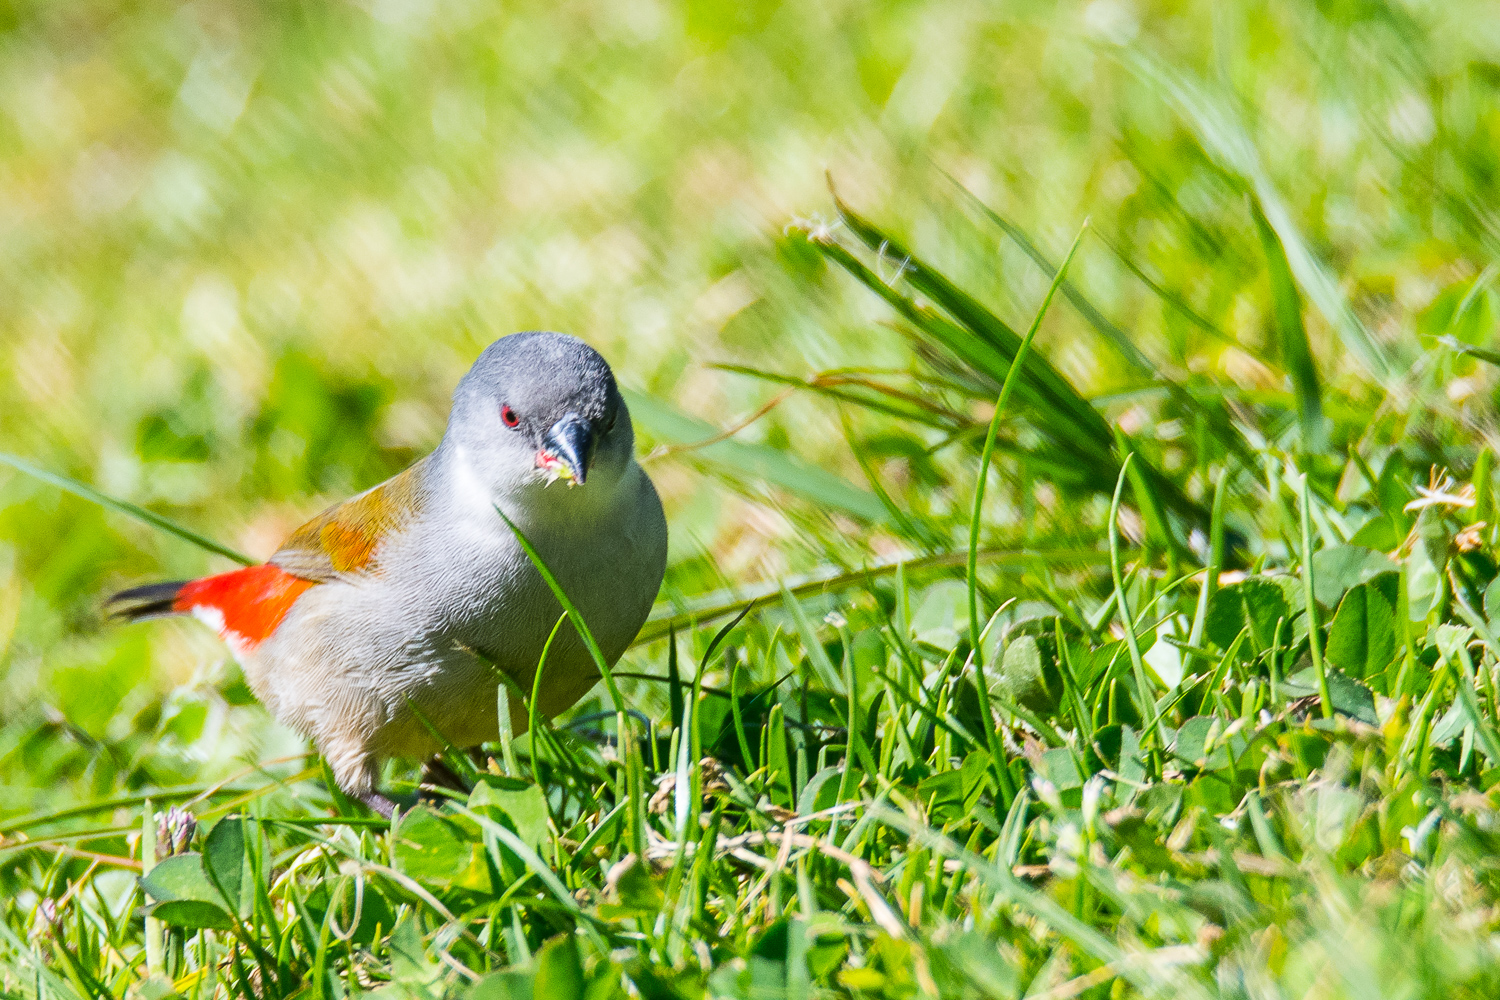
[0, 0, 1500, 1000]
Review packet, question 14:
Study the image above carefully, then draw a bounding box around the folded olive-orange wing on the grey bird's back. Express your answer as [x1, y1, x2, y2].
[270, 462, 423, 583]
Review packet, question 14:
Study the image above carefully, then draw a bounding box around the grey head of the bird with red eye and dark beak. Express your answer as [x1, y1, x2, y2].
[444, 333, 635, 490]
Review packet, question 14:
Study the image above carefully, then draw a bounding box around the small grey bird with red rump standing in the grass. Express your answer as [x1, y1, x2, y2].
[108, 333, 666, 817]
